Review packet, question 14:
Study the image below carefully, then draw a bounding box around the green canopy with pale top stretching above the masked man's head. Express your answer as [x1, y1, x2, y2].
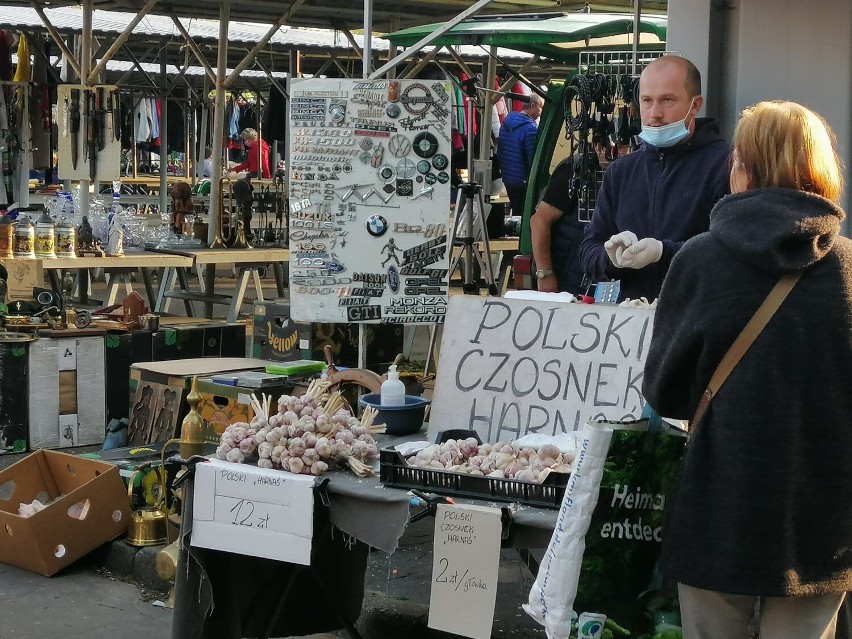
[383, 13, 667, 62]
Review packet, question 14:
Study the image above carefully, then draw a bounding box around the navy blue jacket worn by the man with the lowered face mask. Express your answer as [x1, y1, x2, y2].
[580, 118, 730, 300]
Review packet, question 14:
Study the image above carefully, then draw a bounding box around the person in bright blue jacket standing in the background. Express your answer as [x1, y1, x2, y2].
[497, 93, 543, 220]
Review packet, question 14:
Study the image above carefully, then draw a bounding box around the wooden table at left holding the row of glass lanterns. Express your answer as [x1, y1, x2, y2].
[41, 251, 192, 308]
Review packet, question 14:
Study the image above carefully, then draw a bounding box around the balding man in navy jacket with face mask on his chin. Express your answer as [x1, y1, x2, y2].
[580, 55, 729, 300]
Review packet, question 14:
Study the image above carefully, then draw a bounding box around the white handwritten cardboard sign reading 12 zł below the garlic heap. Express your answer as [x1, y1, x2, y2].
[192, 459, 314, 566]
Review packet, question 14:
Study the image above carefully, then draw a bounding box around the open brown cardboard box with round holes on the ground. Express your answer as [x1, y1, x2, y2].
[0, 450, 131, 577]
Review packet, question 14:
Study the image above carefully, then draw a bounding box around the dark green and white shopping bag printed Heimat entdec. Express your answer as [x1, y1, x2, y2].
[524, 414, 686, 639]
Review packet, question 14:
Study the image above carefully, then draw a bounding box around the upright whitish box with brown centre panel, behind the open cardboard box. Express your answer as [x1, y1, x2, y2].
[28, 329, 106, 448]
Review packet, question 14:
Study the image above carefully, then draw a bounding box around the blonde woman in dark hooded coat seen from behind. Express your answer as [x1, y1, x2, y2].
[643, 101, 852, 639]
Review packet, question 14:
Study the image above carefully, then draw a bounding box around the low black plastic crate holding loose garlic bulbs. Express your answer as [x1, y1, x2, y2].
[379, 431, 571, 509]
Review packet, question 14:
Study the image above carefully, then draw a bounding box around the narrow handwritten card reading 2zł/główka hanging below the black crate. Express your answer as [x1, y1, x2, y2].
[429, 504, 501, 639]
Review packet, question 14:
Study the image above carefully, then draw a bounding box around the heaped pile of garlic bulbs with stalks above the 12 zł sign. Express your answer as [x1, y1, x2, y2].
[216, 380, 384, 477]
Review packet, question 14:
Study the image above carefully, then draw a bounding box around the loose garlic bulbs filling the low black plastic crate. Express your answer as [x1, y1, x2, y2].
[407, 437, 574, 483]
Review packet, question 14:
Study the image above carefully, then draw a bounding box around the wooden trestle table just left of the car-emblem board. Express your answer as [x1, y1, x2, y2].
[154, 247, 290, 322]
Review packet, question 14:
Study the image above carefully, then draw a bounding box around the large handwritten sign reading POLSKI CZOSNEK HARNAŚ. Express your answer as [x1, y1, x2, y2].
[429, 295, 654, 442]
